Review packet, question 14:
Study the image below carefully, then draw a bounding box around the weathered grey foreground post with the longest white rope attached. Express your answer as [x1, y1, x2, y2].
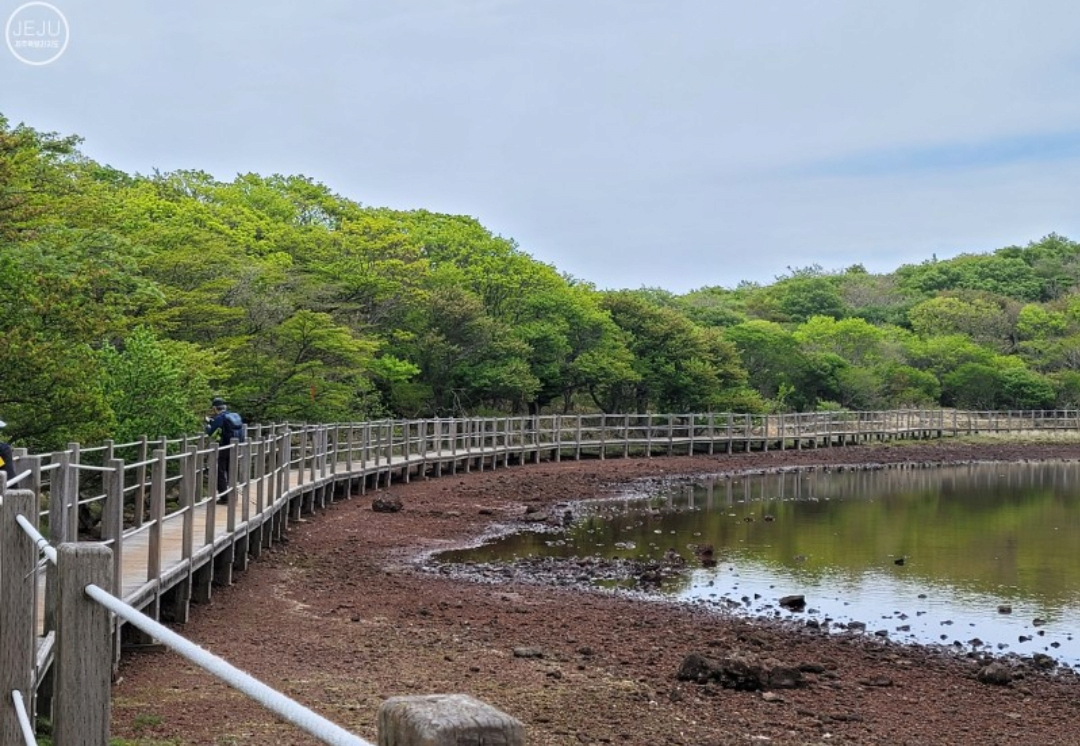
[53, 543, 112, 746]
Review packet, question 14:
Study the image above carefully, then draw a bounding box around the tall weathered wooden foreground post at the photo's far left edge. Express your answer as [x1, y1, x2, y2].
[0, 489, 38, 744]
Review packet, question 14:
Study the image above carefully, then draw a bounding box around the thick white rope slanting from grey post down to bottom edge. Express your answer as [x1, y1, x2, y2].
[85, 584, 375, 746]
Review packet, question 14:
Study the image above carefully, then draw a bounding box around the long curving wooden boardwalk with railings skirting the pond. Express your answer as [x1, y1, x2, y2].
[0, 410, 1080, 746]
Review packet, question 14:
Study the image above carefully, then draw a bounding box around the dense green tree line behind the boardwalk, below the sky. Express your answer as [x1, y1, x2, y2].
[0, 110, 1080, 449]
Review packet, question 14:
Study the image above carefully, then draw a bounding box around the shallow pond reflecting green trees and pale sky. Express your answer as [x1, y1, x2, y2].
[440, 462, 1080, 666]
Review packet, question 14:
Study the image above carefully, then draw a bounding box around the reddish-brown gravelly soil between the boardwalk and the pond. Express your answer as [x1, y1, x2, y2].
[113, 443, 1080, 746]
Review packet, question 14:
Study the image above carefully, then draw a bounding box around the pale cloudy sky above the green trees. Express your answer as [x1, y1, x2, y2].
[0, 0, 1080, 294]
